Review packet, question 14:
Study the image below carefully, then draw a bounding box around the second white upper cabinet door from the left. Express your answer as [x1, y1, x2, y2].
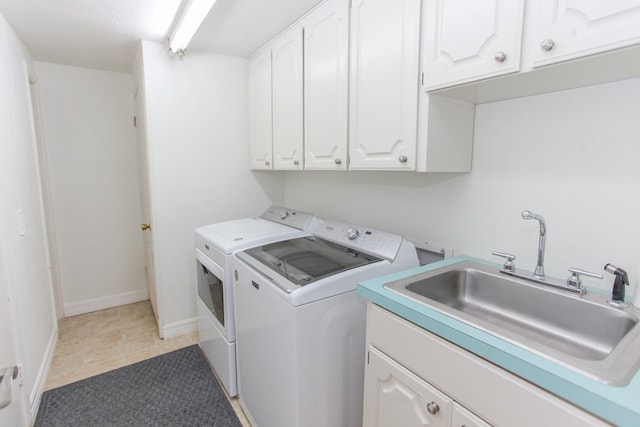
[271, 27, 304, 170]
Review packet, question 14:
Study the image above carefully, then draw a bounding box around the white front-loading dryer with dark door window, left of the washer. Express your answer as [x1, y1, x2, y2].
[195, 206, 319, 396]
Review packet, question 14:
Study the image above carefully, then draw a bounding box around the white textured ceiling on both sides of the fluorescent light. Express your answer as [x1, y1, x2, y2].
[0, 0, 321, 72]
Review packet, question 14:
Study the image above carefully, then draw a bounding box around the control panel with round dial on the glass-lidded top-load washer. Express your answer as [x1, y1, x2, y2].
[314, 220, 404, 261]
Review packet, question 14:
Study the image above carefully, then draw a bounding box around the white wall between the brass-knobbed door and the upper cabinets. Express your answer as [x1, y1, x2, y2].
[140, 42, 284, 336]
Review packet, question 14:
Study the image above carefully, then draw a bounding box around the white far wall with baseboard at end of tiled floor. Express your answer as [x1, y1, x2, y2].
[36, 62, 147, 316]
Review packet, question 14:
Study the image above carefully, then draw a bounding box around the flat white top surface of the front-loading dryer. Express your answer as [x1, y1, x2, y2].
[196, 218, 302, 253]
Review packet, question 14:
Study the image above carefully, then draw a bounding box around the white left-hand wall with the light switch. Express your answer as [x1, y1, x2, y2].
[0, 10, 57, 425]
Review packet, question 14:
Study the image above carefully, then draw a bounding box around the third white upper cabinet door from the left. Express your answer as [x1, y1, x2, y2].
[303, 0, 349, 170]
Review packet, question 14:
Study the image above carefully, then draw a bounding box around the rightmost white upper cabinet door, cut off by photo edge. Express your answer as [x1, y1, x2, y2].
[533, 0, 640, 66]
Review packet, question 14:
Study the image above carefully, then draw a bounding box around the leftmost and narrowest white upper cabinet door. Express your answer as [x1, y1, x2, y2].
[249, 49, 273, 169]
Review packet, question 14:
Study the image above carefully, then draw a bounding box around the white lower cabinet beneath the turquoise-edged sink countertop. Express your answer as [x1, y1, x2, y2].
[363, 302, 609, 427]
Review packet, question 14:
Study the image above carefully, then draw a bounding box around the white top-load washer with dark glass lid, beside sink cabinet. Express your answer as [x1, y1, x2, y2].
[234, 220, 419, 427]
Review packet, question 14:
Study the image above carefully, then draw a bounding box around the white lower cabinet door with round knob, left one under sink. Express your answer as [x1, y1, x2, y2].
[363, 347, 453, 427]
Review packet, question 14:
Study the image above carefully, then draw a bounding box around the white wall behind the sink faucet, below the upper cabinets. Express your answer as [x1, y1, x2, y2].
[285, 79, 640, 294]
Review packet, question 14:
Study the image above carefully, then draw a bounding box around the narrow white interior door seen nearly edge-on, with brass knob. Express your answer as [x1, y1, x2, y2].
[135, 80, 163, 338]
